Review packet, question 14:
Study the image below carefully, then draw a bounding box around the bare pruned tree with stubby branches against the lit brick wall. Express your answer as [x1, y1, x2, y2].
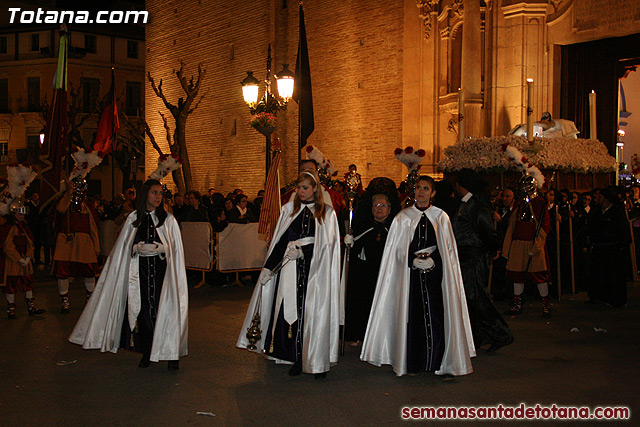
[147, 61, 206, 193]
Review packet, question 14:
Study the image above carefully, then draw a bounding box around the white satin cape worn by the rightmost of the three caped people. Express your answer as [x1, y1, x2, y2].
[360, 206, 476, 376]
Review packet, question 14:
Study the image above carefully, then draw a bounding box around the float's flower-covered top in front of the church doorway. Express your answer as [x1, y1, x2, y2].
[438, 135, 617, 191]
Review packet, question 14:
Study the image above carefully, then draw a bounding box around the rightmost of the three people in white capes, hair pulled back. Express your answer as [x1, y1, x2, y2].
[360, 176, 476, 379]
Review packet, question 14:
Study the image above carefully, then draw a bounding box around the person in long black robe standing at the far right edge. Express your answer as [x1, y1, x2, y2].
[589, 188, 631, 307]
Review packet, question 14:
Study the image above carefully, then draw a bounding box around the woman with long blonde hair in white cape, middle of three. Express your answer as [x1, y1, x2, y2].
[237, 171, 340, 378]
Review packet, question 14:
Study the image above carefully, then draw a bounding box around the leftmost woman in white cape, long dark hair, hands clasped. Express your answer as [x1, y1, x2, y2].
[69, 179, 189, 370]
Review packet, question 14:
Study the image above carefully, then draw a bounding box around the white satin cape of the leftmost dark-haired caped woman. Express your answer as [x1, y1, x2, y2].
[69, 212, 189, 362]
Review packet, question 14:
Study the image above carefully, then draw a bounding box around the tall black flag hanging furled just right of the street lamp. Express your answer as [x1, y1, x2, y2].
[293, 3, 315, 148]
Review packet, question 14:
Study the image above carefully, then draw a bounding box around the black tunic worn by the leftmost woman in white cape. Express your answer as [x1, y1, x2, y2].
[120, 212, 167, 356]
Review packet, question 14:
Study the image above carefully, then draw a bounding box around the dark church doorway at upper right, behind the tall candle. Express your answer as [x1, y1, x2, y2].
[560, 34, 640, 155]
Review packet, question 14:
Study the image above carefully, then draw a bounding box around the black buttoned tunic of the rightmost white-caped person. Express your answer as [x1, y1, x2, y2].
[407, 213, 444, 374]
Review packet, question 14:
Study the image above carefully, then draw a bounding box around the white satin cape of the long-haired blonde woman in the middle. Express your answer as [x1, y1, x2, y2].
[236, 201, 340, 374]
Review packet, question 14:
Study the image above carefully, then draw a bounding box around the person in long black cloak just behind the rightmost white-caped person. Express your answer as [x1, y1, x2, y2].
[452, 169, 513, 353]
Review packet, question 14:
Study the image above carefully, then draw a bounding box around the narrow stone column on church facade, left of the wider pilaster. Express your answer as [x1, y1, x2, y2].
[460, 0, 484, 137]
